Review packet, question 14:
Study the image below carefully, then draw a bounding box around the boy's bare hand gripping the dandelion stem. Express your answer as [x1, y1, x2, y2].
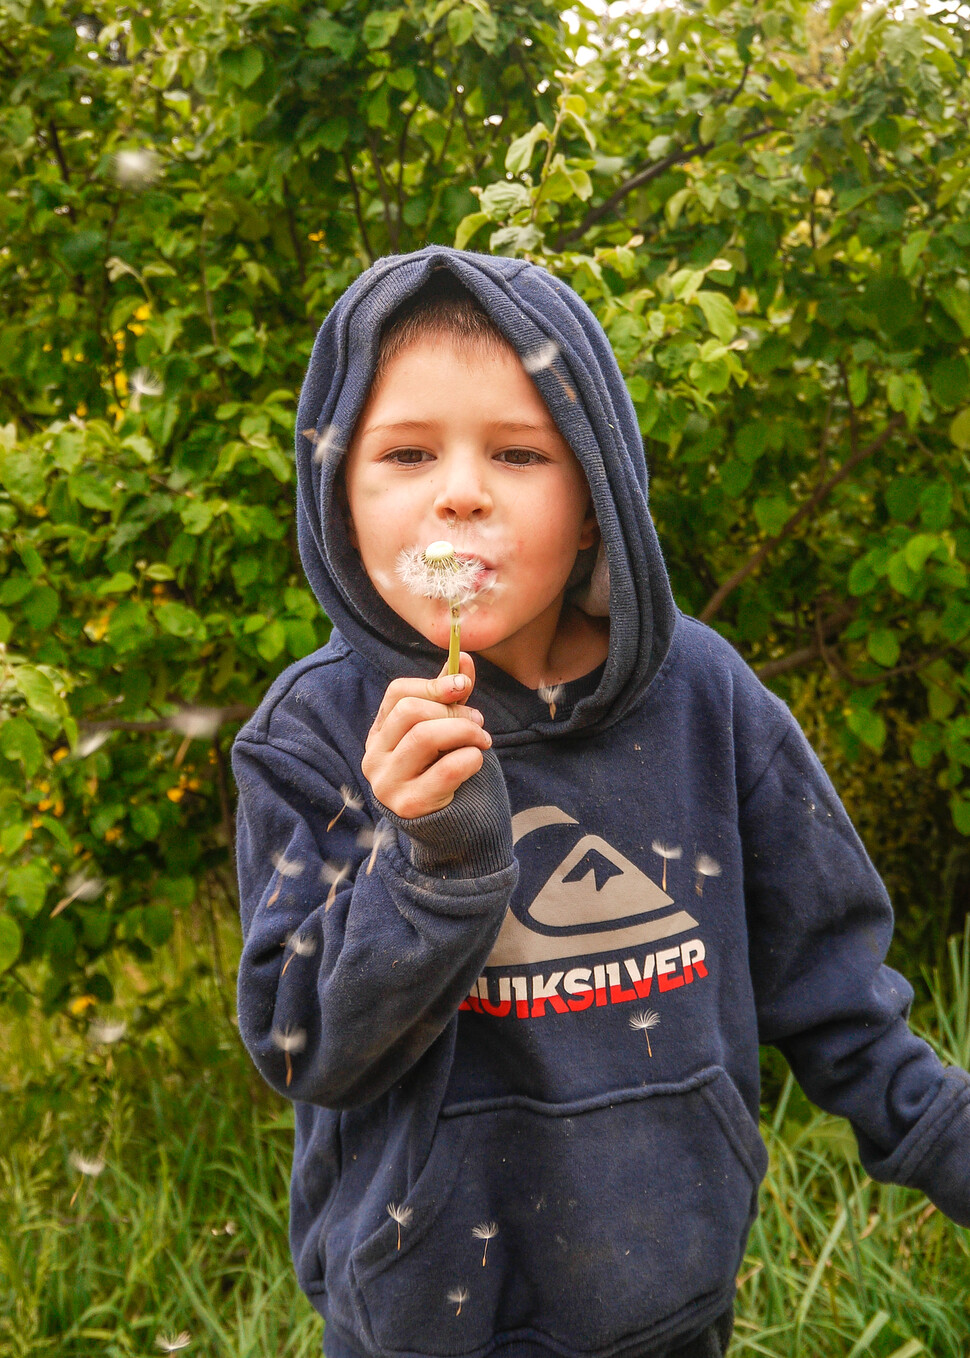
[360, 650, 492, 820]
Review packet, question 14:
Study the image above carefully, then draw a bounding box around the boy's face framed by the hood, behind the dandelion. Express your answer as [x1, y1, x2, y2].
[344, 335, 599, 682]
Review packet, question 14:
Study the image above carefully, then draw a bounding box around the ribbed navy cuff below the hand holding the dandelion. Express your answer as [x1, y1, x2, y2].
[378, 750, 512, 877]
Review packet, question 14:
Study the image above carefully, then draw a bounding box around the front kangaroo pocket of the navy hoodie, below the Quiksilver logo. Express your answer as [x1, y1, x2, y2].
[352, 1066, 768, 1358]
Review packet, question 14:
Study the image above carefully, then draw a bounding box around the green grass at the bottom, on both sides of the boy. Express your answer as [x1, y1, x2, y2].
[0, 921, 970, 1358]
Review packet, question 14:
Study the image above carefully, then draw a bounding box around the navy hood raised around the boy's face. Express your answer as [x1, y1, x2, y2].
[290, 246, 677, 744]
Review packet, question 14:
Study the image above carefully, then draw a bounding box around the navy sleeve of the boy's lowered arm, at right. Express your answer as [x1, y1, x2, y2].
[739, 713, 970, 1226]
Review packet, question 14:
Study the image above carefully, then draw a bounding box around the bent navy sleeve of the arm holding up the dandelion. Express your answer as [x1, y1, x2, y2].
[232, 737, 518, 1108]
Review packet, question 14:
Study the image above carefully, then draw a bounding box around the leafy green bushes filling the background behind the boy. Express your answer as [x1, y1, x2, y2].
[0, 0, 970, 1008]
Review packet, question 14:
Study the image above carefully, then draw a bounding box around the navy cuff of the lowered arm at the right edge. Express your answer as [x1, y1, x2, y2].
[861, 1066, 970, 1226]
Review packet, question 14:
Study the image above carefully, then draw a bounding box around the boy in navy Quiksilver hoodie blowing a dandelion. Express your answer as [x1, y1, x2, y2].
[234, 247, 970, 1358]
